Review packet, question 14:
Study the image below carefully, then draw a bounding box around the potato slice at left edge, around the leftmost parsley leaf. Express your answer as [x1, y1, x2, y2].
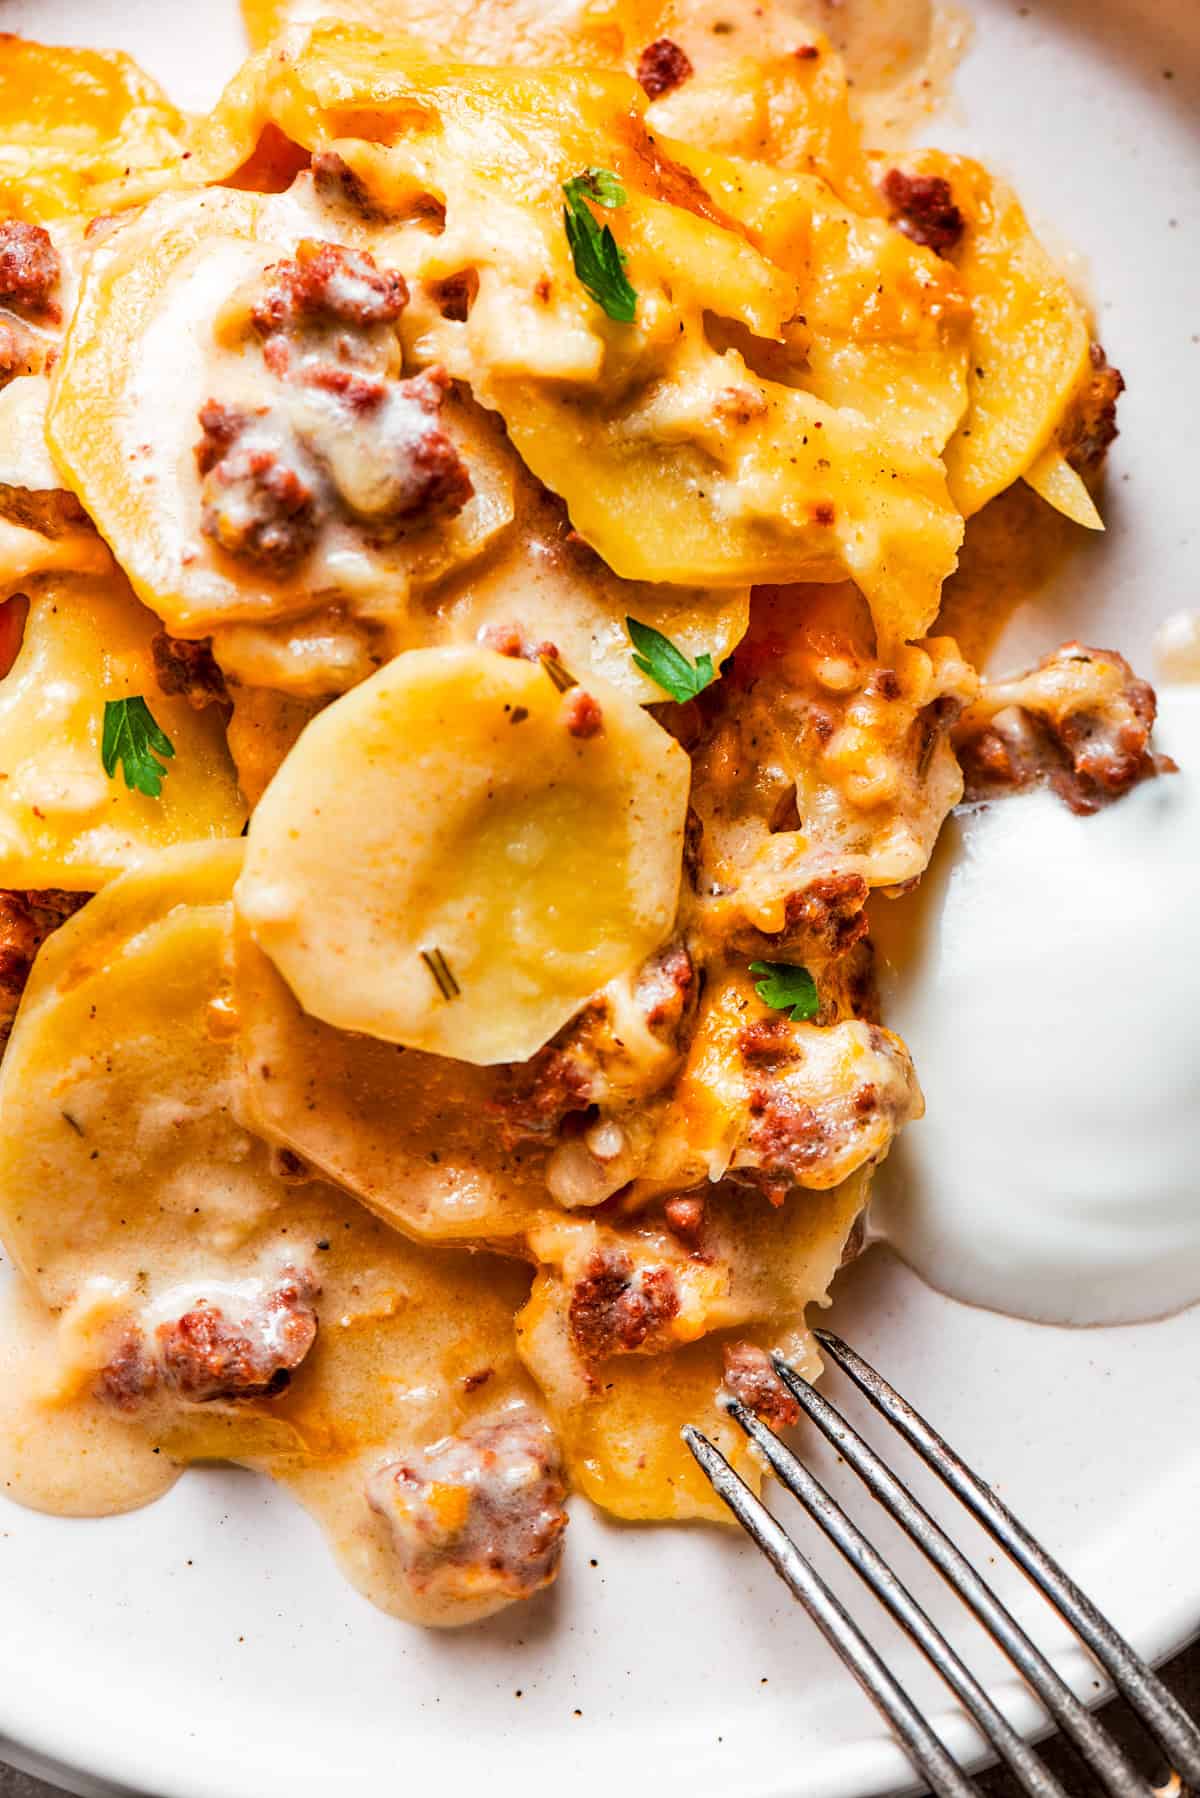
[0, 571, 246, 892]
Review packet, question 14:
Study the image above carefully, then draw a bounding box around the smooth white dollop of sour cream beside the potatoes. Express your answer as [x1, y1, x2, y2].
[873, 687, 1200, 1323]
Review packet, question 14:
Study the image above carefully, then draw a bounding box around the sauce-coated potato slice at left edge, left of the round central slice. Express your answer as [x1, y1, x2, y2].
[0, 841, 255, 1307]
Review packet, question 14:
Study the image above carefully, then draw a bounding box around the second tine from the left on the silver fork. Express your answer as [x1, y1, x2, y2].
[721, 1399, 1065, 1798]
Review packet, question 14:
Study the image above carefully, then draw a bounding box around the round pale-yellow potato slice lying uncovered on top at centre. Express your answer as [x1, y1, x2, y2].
[236, 647, 689, 1066]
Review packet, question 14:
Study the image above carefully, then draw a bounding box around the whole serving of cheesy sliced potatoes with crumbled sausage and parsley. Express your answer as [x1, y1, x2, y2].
[0, 0, 1169, 1624]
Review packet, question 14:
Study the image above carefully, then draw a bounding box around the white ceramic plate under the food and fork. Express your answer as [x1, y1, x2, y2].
[0, 0, 1200, 1798]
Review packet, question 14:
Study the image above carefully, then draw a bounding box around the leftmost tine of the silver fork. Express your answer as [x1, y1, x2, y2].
[680, 1424, 979, 1798]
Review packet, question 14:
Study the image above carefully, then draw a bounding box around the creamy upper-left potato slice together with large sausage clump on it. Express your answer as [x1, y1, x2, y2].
[47, 182, 513, 640]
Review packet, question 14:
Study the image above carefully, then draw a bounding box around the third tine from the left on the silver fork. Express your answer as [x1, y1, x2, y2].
[772, 1354, 1151, 1798]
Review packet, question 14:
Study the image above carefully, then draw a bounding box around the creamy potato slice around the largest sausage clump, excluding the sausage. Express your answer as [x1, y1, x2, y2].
[47, 183, 513, 640]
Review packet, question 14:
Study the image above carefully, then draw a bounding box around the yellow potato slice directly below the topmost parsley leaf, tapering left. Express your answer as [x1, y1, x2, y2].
[497, 361, 963, 645]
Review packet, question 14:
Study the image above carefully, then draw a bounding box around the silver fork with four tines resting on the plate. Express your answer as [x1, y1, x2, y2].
[684, 1331, 1200, 1798]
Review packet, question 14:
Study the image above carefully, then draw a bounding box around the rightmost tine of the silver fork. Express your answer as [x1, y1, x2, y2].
[817, 1331, 1200, 1787]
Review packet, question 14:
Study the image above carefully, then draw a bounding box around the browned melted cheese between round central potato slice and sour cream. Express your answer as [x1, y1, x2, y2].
[693, 586, 977, 937]
